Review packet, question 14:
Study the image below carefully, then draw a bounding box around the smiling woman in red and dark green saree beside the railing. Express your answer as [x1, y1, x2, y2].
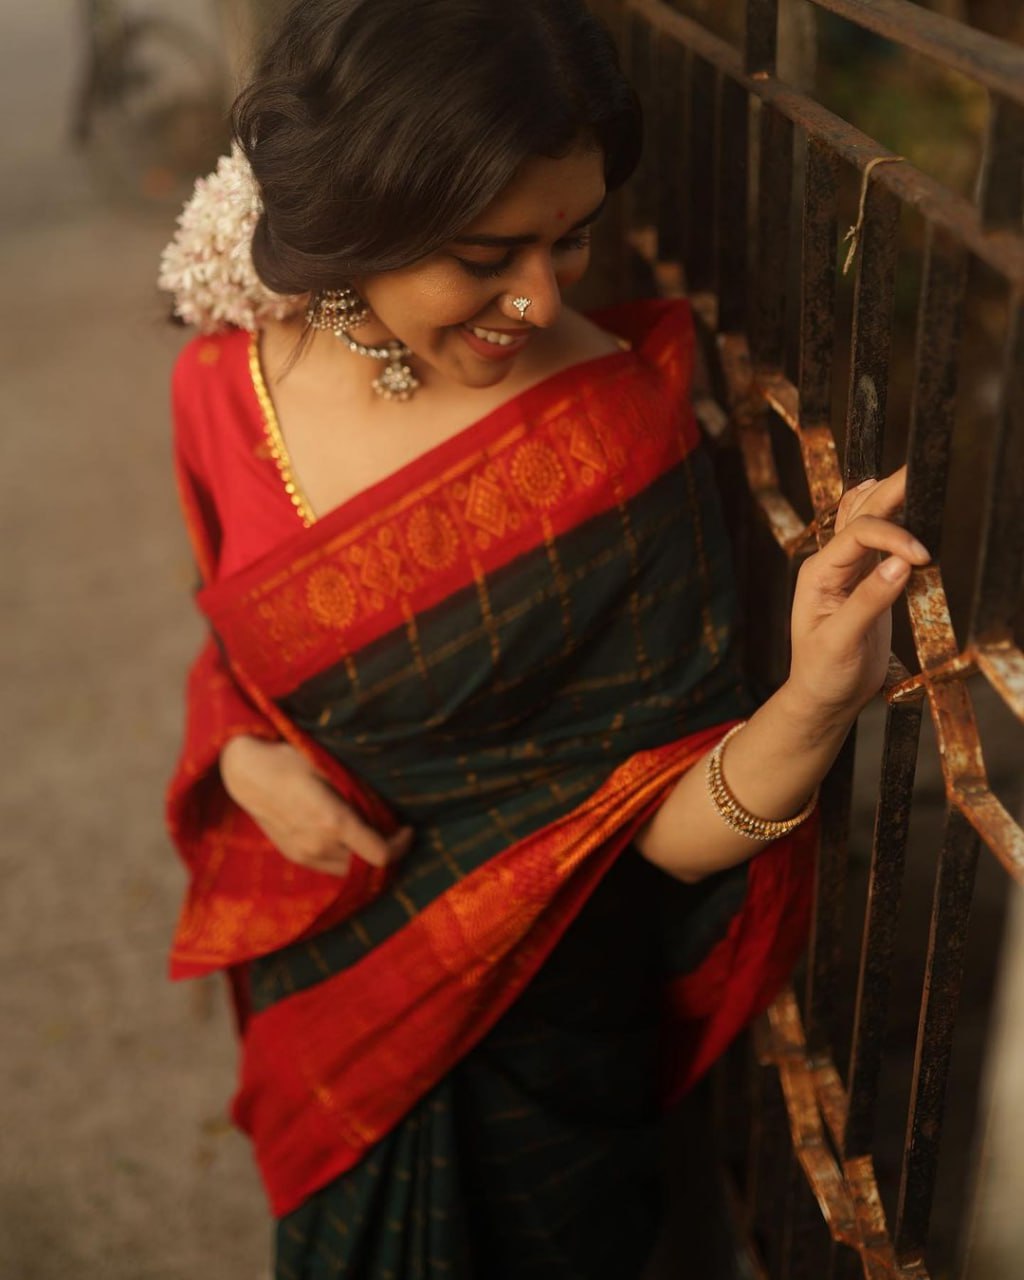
[165, 0, 927, 1280]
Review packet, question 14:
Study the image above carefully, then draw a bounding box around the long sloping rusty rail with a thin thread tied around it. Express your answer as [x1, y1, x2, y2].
[623, 0, 1024, 288]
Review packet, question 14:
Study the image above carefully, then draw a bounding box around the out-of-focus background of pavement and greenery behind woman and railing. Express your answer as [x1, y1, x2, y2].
[0, 0, 1024, 1280]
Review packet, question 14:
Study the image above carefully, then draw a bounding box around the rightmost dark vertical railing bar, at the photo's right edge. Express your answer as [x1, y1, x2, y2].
[970, 300, 1024, 650]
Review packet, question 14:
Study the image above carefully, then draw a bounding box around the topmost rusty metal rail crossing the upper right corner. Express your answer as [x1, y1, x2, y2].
[812, 0, 1024, 102]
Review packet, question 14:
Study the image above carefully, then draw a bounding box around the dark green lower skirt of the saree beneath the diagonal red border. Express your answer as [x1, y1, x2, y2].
[278, 855, 691, 1280]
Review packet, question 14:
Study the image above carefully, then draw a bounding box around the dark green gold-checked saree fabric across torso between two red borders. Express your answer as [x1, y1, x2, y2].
[252, 451, 745, 1009]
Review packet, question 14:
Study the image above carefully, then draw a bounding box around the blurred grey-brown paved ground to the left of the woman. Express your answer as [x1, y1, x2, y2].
[0, 0, 1018, 1280]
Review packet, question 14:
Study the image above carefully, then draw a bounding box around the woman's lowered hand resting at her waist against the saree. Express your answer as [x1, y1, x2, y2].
[220, 735, 412, 876]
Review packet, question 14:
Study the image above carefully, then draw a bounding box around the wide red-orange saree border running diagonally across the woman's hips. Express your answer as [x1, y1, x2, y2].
[233, 726, 742, 1216]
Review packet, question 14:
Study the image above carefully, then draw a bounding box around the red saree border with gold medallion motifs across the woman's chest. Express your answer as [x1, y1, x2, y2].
[200, 357, 698, 698]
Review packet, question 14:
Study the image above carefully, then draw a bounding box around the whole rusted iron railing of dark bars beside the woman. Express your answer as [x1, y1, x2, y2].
[594, 0, 1024, 1280]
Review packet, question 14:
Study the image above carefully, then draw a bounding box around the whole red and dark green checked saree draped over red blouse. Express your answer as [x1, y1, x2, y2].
[170, 303, 815, 1280]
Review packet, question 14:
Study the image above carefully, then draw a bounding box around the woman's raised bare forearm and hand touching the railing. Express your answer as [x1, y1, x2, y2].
[636, 468, 929, 881]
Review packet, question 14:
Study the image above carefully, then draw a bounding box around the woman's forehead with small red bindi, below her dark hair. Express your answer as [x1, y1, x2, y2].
[466, 147, 604, 236]
